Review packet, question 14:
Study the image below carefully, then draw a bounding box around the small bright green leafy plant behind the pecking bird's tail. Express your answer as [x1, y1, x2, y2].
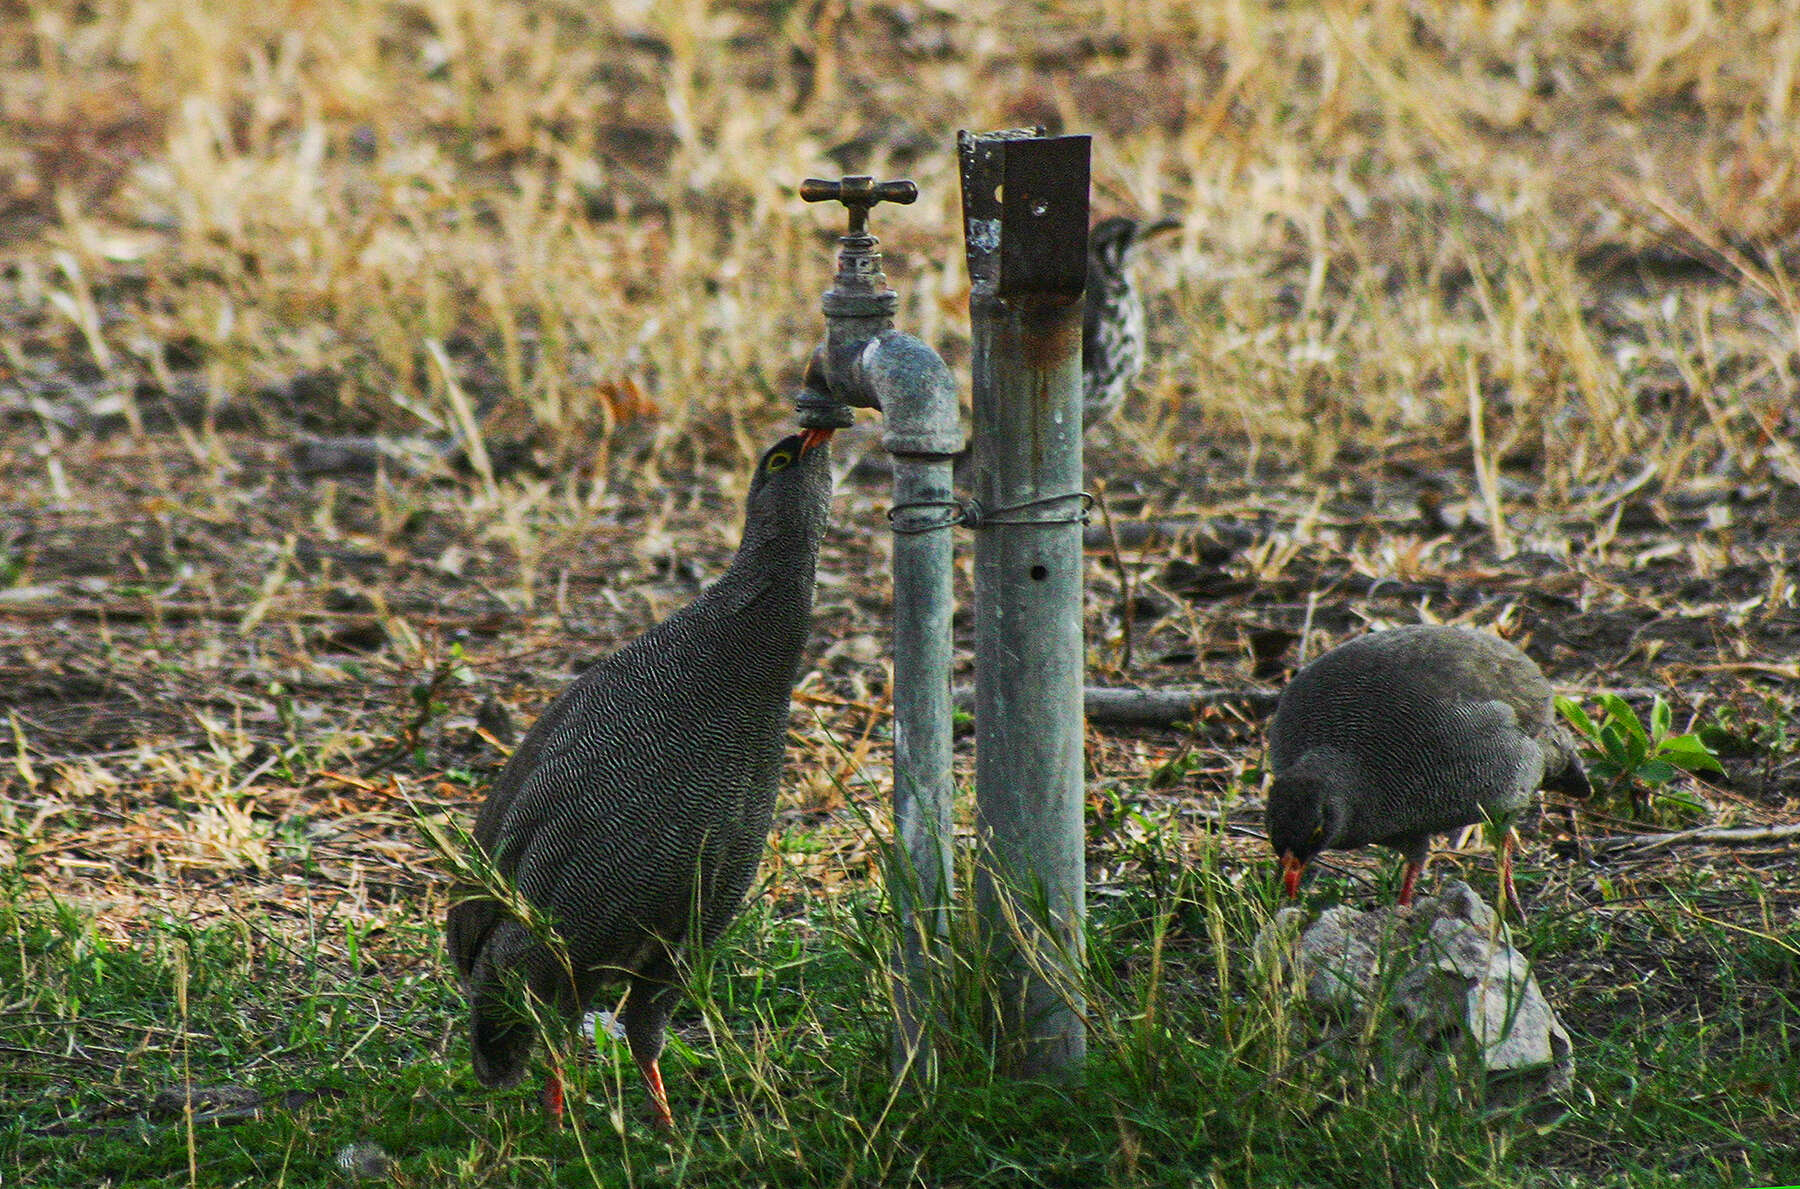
[1557, 694, 1724, 815]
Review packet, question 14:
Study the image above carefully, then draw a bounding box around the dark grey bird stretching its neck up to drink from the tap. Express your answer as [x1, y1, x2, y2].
[448, 430, 832, 1128]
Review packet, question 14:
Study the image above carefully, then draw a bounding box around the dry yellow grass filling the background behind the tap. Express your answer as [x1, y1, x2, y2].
[0, 0, 1800, 478]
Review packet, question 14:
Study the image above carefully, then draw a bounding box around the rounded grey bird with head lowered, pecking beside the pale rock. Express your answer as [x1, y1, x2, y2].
[1267, 624, 1588, 905]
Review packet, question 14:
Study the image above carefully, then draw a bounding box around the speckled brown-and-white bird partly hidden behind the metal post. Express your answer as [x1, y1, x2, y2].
[1082, 216, 1181, 428]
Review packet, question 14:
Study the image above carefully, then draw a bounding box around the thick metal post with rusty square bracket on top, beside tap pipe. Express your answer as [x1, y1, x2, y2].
[959, 133, 1087, 1076]
